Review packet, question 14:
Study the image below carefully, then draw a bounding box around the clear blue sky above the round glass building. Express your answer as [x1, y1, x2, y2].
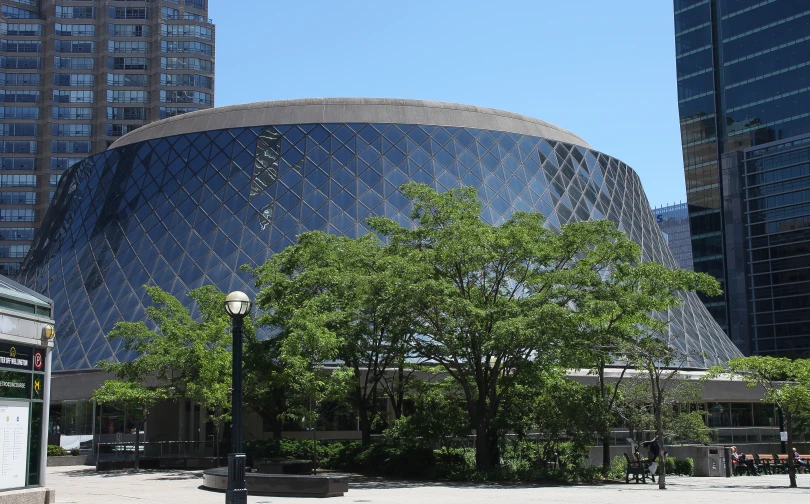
[209, 0, 686, 209]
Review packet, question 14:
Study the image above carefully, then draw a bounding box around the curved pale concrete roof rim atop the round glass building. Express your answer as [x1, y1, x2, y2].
[110, 98, 590, 149]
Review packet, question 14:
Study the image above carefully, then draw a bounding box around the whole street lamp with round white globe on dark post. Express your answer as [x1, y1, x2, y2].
[225, 291, 250, 504]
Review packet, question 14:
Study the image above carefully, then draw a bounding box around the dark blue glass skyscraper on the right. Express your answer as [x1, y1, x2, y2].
[674, 0, 810, 355]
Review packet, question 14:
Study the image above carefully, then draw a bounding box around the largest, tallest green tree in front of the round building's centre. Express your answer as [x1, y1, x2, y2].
[368, 184, 652, 469]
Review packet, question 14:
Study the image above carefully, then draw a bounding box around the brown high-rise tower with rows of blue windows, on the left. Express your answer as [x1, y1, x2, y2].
[0, 0, 214, 275]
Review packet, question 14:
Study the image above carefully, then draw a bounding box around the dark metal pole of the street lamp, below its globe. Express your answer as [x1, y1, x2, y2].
[225, 317, 247, 504]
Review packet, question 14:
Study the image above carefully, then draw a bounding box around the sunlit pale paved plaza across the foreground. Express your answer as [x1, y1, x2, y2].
[48, 467, 810, 504]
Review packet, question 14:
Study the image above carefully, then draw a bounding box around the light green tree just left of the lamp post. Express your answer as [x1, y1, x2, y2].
[99, 286, 235, 459]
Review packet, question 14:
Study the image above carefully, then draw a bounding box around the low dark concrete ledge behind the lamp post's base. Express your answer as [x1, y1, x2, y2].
[203, 467, 349, 497]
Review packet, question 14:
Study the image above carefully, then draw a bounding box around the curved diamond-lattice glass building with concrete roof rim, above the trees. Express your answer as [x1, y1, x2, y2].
[22, 101, 738, 370]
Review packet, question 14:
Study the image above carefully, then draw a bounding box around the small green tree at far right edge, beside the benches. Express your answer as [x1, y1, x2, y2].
[707, 356, 810, 488]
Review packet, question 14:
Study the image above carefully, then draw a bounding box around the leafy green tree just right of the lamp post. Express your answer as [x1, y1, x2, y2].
[253, 231, 413, 444]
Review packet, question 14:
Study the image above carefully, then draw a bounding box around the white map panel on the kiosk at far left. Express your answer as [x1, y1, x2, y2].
[0, 401, 28, 490]
